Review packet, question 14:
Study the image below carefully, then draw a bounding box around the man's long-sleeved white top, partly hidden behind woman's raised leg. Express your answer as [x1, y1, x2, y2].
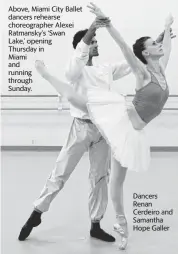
[66, 40, 131, 119]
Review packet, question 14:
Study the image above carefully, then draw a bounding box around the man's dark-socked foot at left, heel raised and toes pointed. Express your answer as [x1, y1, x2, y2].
[18, 210, 42, 241]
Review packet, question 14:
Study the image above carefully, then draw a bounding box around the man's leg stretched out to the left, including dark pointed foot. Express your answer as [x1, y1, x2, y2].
[19, 118, 90, 241]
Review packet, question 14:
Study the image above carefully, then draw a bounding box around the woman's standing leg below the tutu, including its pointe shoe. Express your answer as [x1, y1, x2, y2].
[111, 158, 128, 249]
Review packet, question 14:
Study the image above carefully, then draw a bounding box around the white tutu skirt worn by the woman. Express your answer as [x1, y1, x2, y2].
[87, 88, 150, 172]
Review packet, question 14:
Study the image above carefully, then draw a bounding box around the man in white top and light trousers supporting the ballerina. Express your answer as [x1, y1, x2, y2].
[19, 16, 171, 242]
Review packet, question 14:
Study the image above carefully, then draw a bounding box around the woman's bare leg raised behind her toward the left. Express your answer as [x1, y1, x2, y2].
[35, 60, 88, 112]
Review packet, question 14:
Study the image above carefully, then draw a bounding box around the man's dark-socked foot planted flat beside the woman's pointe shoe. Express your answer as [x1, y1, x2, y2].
[90, 222, 115, 242]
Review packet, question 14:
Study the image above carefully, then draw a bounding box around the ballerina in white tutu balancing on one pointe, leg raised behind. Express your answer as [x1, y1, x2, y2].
[36, 4, 173, 249]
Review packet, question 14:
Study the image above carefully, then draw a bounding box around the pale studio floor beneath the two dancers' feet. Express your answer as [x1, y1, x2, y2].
[2, 152, 178, 254]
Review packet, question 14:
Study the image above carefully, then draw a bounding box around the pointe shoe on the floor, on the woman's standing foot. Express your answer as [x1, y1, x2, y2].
[114, 216, 128, 250]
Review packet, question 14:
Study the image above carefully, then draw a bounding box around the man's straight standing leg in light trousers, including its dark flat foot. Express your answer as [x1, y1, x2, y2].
[89, 131, 115, 242]
